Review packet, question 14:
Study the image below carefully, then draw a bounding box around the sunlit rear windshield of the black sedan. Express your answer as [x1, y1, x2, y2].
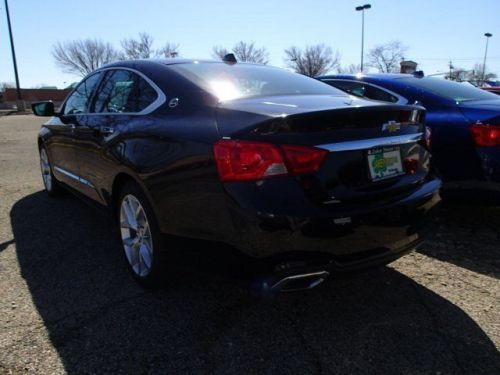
[169, 62, 346, 101]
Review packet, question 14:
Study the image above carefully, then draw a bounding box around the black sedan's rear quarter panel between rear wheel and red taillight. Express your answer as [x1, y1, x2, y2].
[103, 106, 235, 244]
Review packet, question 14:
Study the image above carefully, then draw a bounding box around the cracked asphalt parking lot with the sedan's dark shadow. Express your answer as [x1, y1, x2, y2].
[0, 116, 500, 374]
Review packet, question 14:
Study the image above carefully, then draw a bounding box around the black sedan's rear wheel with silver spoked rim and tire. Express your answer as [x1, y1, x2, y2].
[115, 182, 167, 289]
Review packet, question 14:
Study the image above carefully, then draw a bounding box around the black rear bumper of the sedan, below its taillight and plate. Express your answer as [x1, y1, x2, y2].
[225, 180, 441, 271]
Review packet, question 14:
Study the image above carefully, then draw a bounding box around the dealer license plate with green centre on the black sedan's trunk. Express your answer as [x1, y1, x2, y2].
[368, 147, 404, 181]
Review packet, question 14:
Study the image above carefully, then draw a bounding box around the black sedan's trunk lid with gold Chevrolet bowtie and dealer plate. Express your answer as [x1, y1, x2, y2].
[218, 96, 429, 207]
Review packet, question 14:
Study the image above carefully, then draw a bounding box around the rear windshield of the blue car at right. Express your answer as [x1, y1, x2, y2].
[399, 77, 498, 103]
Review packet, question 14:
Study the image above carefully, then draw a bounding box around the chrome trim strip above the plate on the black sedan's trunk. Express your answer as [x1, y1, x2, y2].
[316, 133, 424, 152]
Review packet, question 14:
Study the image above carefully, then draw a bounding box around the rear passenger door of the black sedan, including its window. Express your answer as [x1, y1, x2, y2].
[70, 68, 164, 203]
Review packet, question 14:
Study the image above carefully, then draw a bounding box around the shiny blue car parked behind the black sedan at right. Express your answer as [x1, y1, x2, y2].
[318, 74, 500, 192]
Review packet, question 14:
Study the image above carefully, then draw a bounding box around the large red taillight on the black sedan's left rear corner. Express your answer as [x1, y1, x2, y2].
[214, 139, 328, 181]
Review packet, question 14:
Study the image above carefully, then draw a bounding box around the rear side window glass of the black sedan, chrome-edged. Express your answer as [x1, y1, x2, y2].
[93, 70, 158, 113]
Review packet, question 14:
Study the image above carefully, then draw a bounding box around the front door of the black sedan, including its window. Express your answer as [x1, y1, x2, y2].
[45, 73, 101, 191]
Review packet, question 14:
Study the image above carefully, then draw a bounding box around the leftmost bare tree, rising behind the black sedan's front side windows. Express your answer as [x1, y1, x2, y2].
[52, 39, 119, 76]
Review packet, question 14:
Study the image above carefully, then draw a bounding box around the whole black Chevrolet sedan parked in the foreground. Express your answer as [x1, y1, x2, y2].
[33, 58, 440, 290]
